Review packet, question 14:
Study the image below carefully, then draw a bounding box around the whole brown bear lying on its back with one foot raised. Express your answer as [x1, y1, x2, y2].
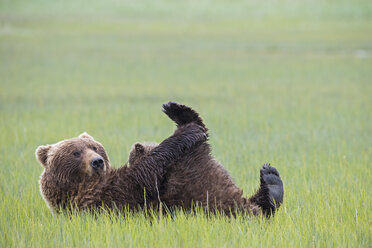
[36, 103, 283, 215]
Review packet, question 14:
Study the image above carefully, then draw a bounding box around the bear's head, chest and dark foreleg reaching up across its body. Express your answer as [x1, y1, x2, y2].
[36, 117, 207, 213]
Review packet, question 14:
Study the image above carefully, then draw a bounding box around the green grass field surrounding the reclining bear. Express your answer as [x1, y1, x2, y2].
[0, 0, 372, 247]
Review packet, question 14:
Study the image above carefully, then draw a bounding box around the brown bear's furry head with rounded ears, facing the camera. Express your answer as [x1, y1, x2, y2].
[35, 133, 110, 210]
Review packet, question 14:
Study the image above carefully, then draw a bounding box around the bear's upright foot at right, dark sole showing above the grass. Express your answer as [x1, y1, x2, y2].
[249, 164, 284, 216]
